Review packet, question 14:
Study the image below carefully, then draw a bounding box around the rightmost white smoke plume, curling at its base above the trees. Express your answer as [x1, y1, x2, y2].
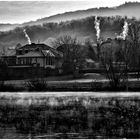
[117, 21, 128, 40]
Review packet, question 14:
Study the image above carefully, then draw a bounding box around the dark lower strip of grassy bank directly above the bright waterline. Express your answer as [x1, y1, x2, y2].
[0, 79, 140, 92]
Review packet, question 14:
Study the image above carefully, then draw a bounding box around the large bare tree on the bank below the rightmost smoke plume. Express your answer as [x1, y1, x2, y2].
[101, 40, 130, 90]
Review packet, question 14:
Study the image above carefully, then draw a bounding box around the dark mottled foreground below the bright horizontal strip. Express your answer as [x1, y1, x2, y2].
[0, 95, 140, 138]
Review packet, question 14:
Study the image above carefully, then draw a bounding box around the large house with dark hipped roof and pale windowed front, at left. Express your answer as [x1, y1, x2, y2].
[1, 43, 63, 69]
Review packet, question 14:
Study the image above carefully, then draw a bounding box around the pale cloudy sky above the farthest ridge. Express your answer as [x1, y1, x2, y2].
[0, 0, 140, 24]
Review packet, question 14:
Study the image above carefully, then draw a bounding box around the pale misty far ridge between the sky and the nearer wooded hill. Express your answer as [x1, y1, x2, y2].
[0, 2, 140, 31]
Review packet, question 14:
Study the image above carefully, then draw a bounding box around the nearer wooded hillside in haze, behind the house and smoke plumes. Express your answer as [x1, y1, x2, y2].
[0, 16, 127, 53]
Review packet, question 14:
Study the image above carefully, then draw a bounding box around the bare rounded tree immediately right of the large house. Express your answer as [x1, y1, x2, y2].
[53, 35, 84, 77]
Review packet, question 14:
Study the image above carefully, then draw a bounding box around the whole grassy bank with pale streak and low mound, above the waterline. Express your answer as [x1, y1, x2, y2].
[0, 73, 140, 92]
